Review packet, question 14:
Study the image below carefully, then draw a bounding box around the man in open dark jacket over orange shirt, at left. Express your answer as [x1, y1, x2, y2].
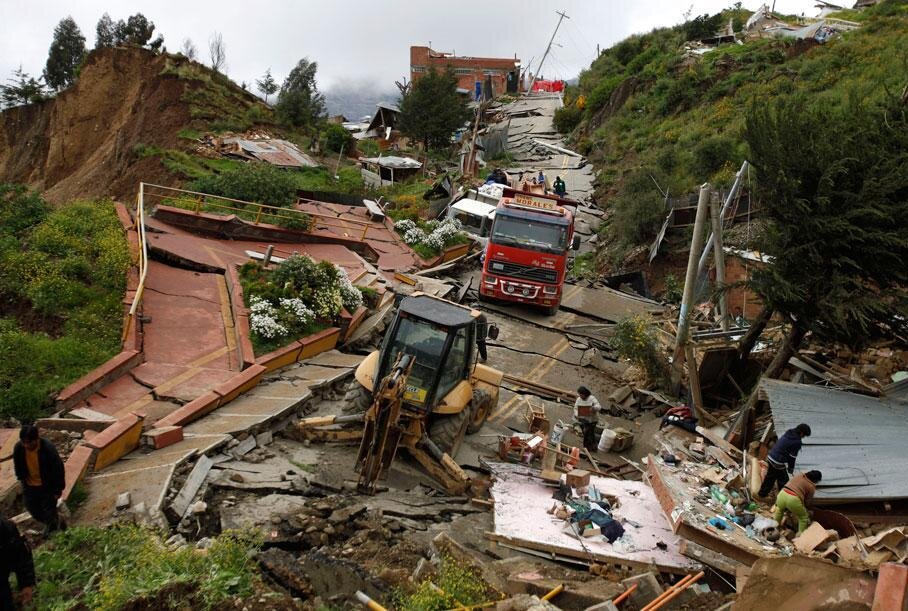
[13, 424, 66, 533]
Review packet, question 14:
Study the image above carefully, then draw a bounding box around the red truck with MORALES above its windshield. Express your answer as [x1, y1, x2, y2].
[479, 187, 580, 314]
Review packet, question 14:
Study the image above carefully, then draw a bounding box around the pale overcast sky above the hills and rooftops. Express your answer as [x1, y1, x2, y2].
[0, 0, 816, 95]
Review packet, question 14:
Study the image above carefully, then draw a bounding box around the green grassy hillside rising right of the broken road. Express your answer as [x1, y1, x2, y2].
[556, 0, 908, 267]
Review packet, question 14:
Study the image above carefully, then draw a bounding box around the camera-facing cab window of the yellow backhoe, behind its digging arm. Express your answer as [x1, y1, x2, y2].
[382, 318, 448, 403]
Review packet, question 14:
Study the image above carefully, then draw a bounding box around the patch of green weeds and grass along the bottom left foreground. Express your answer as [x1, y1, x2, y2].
[34, 525, 260, 610]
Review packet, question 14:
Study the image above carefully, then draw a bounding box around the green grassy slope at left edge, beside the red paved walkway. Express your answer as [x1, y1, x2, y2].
[0, 185, 129, 421]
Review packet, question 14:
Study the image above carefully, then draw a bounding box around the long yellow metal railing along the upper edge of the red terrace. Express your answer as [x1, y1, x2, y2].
[140, 183, 372, 242]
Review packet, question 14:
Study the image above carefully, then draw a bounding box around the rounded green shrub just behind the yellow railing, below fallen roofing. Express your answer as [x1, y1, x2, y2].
[190, 162, 297, 207]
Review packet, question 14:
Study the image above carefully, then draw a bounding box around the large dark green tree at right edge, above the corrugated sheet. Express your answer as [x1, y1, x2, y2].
[745, 97, 908, 348]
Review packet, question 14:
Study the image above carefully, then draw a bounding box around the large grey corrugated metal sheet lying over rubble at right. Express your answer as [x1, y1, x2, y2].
[762, 380, 908, 503]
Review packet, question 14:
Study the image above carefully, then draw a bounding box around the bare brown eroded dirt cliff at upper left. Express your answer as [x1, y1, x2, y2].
[0, 48, 255, 202]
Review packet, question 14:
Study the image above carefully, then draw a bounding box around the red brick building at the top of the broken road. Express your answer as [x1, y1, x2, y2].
[410, 47, 520, 96]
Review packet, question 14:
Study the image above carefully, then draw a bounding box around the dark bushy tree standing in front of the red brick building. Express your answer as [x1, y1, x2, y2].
[398, 68, 470, 148]
